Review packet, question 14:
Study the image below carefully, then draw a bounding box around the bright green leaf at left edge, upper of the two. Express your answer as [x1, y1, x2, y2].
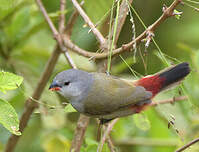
[0, 71, 23, 93]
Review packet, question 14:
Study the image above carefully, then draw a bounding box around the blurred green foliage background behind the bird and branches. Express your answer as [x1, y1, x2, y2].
[0, 0, 199, 152]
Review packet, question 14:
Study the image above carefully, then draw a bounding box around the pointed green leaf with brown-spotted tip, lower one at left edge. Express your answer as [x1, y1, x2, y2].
[0, 99, 21, 136]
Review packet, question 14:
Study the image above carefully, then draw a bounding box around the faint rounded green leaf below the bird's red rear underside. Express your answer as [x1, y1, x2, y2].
[133, 113, 151, 131]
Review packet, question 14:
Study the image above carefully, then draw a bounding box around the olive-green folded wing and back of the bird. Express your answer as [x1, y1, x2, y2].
[84, 73, 152, 114]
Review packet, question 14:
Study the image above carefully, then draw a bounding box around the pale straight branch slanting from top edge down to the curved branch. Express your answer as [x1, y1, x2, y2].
[71, 0, 106, 48]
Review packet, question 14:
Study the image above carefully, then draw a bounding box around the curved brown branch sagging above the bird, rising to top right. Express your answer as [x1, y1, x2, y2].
[61, 0, 181, 59]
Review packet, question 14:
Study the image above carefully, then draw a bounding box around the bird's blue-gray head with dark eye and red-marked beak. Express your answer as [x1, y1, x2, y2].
[49, 69, 93, 101]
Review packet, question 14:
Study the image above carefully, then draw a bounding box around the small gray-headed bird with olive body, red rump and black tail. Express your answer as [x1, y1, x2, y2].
[49, 62, 190, 124]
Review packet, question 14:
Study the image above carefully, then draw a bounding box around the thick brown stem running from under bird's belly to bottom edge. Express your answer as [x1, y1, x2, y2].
[70, 114, 90, 152]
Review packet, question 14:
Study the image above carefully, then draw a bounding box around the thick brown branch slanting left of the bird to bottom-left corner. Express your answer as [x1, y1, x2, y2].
[5, 47, 61, 152]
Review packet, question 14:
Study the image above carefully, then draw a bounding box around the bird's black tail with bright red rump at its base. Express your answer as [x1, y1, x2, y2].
[136, 62, 190, 96]
